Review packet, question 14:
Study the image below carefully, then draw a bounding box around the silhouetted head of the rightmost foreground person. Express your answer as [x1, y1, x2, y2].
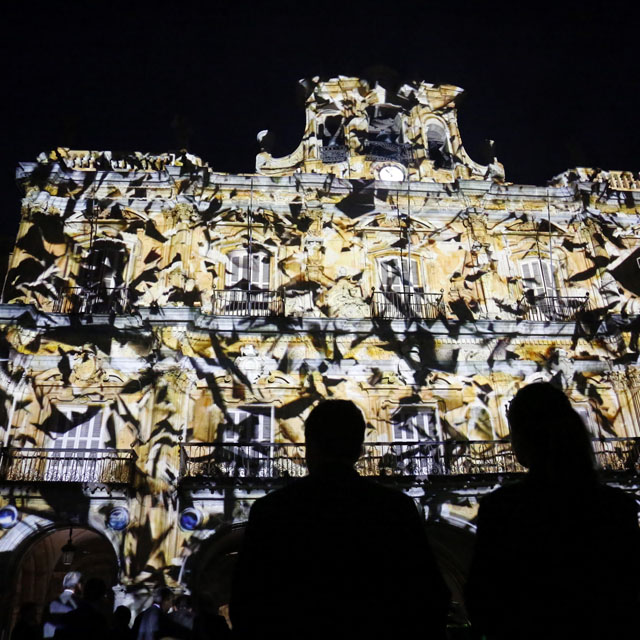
[507, 382, 595, 481]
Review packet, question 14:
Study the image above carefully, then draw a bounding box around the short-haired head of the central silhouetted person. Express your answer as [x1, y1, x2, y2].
[304, 400, 366, 473]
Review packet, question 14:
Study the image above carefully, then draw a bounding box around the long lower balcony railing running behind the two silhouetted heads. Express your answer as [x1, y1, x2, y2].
[180, 438, 640, 481]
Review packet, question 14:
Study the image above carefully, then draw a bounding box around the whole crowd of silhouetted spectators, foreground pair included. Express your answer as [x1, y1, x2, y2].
[11, 383, 640, 640]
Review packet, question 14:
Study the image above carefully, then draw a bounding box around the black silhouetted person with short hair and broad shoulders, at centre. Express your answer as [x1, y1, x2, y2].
[230, 400, 449, 639]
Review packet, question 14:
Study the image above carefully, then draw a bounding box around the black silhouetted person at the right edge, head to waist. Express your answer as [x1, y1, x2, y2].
[466, 383, 640, 640]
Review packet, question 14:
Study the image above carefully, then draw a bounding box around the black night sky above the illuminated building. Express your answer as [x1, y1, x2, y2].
[0, 0, 640, 233]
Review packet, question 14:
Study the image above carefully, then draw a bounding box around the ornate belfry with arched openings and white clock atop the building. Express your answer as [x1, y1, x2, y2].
[256, 76, 504, 182]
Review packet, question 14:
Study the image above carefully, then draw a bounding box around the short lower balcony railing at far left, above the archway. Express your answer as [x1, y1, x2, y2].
[0, 447, 136, 484]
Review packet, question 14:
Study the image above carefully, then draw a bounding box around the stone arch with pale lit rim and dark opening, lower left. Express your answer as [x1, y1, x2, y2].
[0, 516, 121, 629]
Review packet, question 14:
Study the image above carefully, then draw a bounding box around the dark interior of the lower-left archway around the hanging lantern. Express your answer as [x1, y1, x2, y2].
[3, 527, 118, 637]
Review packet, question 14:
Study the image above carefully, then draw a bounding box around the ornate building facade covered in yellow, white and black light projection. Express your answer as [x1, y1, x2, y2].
[0, 77, 640, 627]
